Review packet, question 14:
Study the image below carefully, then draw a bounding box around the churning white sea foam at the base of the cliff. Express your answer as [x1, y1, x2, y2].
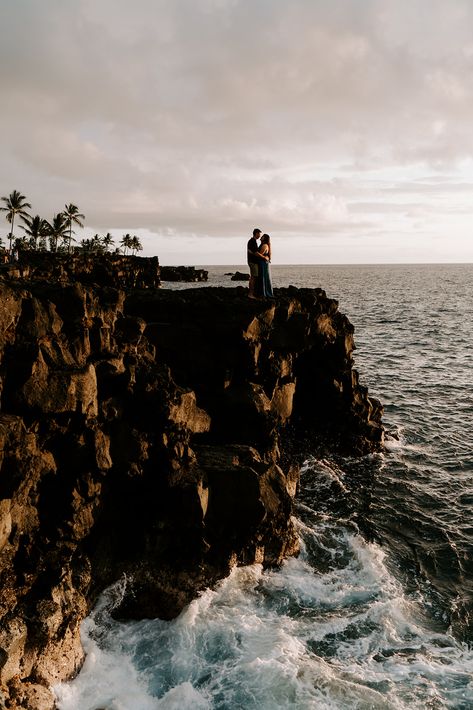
[55, 523, 473, 710]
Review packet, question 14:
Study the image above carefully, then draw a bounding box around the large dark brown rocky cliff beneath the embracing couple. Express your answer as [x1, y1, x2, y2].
[0, 280, 382, 710]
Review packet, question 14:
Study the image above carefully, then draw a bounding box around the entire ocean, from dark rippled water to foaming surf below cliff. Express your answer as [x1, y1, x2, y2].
[55, 265, 473, 710]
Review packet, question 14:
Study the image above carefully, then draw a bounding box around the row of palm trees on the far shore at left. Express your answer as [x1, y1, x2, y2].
[0, 190, 143, 257]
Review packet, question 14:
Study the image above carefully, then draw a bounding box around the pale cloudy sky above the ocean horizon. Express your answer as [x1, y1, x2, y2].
[0, 0, 473, 265]
